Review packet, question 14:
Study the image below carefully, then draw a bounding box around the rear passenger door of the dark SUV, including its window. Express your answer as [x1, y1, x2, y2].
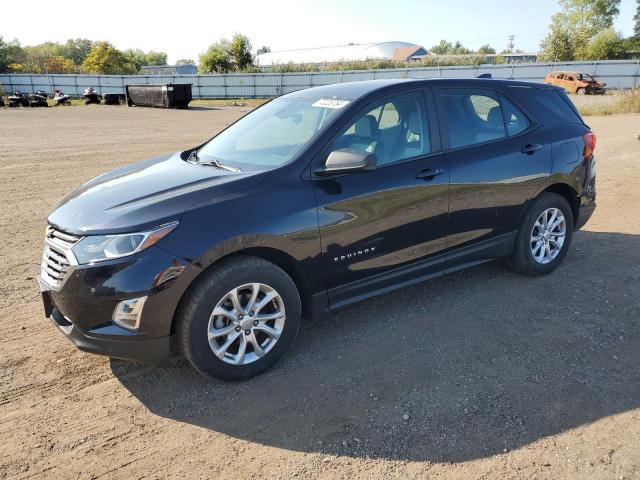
[436, 87, 552, 261]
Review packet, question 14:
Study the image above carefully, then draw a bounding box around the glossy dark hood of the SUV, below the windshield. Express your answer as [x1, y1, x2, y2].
[48, 153, 267, 235]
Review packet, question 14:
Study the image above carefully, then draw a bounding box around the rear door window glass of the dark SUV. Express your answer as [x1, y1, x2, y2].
[440, 88, 507, 148]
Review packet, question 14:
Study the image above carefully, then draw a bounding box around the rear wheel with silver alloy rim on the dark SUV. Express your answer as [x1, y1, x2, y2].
[509, 192, 573, 276]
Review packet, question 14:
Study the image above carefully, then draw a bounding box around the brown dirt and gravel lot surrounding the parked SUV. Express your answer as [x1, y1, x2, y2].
[0, 106, 640, 479]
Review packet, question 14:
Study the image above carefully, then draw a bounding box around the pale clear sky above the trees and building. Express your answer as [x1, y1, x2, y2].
[0, 0, 636, 63]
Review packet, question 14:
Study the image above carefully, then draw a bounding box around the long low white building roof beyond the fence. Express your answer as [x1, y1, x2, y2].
[257, 42, 424, 67]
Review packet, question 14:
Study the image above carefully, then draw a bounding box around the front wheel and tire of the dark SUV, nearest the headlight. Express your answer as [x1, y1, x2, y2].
[176, 255, 302, 380]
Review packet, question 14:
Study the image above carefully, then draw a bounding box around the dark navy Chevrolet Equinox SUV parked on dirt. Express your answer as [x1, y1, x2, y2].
[39, 79, 596, 379]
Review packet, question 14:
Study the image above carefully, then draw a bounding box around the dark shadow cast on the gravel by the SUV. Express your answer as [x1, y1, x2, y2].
[111, 232, 640, 462]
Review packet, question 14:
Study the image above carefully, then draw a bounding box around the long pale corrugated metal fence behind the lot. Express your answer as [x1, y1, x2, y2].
[0, 60, 640, 98]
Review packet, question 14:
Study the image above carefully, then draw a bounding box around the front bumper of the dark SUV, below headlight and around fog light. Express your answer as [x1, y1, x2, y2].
[38, 247, 195, 365]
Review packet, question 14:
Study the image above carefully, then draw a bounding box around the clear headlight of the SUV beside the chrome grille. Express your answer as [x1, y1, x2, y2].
[72, 222, 178, 265]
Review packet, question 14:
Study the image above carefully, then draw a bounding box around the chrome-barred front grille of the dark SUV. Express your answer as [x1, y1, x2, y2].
[40, 226, 82, 287]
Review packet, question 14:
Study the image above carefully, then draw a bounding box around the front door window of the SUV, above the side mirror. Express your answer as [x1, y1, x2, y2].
[331, 93, 431, 165]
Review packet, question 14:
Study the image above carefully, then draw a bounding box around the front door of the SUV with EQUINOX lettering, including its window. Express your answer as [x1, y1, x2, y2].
[313, 90, 449, 306]
